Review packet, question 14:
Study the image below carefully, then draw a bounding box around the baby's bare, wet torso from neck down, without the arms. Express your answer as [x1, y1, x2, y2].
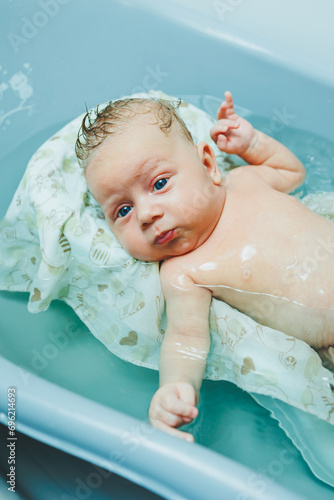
[176, 173, 334, 346]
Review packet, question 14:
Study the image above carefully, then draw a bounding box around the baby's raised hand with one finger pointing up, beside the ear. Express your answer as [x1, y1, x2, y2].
[210, 91, 255, 156]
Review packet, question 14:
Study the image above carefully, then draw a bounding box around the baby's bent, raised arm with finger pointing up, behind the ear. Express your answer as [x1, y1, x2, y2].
[211, 92, 305, 192]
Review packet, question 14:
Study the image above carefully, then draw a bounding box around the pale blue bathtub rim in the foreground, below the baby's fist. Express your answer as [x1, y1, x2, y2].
[0, 355, 303, 500]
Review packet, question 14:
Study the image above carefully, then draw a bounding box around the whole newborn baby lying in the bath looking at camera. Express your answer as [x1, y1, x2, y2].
[76, 92, 334, 440]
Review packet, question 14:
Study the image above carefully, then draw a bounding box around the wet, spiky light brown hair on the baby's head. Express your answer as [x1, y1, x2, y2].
[75, 98, 195, 171]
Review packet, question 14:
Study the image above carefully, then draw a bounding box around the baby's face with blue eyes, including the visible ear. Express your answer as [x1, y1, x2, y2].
[86, 114, 225, 261]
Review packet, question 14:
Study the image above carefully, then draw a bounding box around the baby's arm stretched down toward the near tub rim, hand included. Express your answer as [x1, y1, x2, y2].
[149, 259, 211, 441]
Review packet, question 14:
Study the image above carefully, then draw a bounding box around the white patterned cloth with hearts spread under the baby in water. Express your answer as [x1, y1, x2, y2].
[0, 91, 334, 423]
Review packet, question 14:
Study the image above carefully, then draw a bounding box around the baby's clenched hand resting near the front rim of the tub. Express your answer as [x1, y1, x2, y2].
[149, 382, 198, 442]
